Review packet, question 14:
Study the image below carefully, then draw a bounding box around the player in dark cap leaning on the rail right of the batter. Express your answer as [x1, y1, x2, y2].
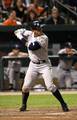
[58, 42, 77, 89]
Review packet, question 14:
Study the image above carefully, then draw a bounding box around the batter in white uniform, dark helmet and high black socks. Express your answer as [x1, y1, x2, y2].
[15, 21, 69, 112]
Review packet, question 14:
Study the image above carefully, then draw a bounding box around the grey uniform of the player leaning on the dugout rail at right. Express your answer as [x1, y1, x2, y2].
[57, 48, 77, 88]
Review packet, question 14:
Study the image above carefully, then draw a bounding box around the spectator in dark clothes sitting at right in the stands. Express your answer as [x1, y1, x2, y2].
[45, 6, 65, 25]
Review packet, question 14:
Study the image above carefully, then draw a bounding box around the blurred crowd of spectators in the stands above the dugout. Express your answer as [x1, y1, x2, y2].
[0, 0, 77, 26]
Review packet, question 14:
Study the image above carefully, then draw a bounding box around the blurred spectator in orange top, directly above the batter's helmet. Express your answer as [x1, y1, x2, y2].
[28, 0, 48, 23]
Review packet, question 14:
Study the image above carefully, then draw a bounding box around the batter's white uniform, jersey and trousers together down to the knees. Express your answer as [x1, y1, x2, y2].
[15, 29, 57, 92]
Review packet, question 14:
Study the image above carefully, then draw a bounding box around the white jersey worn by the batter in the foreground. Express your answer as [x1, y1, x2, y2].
[15, 29, 48, 62]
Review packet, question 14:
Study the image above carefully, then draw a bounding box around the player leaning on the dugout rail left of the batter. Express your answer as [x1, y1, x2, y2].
[7, 44, 28, 90]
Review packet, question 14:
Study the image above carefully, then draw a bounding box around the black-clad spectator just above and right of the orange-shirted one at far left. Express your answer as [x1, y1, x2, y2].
[14, 0, 27, 23]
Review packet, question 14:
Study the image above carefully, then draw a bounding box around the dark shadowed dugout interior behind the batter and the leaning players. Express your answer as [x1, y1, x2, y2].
[0, 25, 77, 89]
